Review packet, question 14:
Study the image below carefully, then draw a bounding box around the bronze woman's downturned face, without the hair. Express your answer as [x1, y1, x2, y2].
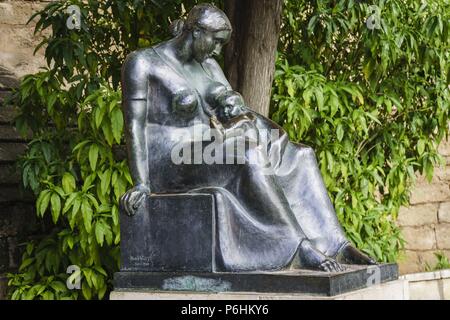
[192, 28, 231, 63]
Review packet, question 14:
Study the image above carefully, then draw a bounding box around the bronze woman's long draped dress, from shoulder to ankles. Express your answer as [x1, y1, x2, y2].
[122, 47, 348, 271]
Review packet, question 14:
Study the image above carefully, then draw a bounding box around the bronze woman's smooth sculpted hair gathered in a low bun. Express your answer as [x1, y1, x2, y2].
[170, 3, 232, 37]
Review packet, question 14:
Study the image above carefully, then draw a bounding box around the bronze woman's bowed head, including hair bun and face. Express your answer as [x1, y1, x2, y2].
[171, 4, 232, 62]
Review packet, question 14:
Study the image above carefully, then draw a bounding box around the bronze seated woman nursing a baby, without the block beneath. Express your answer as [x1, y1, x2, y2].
[120, 4, 375, 272]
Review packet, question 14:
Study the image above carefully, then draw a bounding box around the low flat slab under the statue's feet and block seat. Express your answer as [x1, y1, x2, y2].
[114, 264, 398, 296]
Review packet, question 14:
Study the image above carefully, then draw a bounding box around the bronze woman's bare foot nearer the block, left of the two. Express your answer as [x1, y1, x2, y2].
[298, 240, 344, 272]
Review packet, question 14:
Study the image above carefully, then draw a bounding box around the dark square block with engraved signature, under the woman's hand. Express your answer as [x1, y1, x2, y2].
[120, 194, 215, 272]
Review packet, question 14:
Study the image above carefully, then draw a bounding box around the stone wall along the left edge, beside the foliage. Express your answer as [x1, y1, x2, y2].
[0, 1, 46, 299]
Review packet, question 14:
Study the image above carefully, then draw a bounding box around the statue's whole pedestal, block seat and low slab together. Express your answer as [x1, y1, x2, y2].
[118, 194, 398, 296]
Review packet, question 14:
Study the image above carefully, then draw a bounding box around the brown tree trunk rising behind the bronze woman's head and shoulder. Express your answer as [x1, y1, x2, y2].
[225, 0, 283, 116]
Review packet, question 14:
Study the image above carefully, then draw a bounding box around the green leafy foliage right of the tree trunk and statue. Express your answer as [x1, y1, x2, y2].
[273, 0, 450, 261]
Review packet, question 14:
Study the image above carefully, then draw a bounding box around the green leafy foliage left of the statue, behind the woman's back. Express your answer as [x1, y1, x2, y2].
[9, 0, 209, 299]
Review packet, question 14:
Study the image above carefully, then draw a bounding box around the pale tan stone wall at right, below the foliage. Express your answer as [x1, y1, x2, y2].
[397, 142, 450, 274]
